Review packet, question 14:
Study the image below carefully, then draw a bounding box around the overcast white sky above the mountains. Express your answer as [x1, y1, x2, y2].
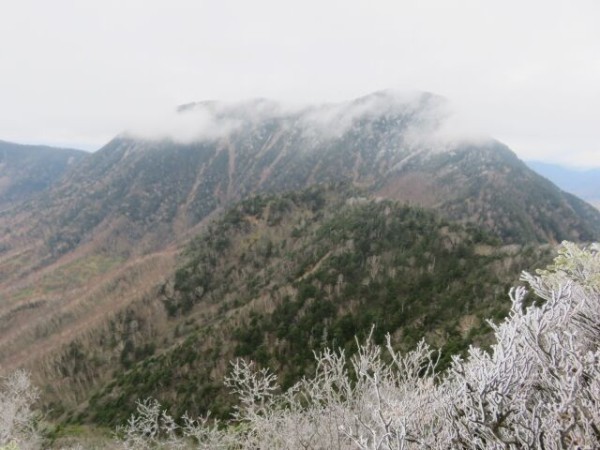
[0, 0, 600, 167]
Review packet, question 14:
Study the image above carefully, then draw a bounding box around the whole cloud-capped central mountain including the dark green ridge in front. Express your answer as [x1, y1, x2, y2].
[0, 91, 600, 432]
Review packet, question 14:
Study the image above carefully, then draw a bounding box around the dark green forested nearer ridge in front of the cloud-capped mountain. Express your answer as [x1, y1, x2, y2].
[62, 185, 550, 423]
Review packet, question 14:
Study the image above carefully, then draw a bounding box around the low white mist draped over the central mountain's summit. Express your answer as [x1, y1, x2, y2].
[125, 90, 490, 156]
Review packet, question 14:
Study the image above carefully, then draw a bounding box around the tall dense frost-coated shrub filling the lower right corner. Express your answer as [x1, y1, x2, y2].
[437, 243, 600, 449]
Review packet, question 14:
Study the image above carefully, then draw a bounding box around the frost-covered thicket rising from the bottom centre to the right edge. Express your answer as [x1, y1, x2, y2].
[116, 243, 600, 449]
